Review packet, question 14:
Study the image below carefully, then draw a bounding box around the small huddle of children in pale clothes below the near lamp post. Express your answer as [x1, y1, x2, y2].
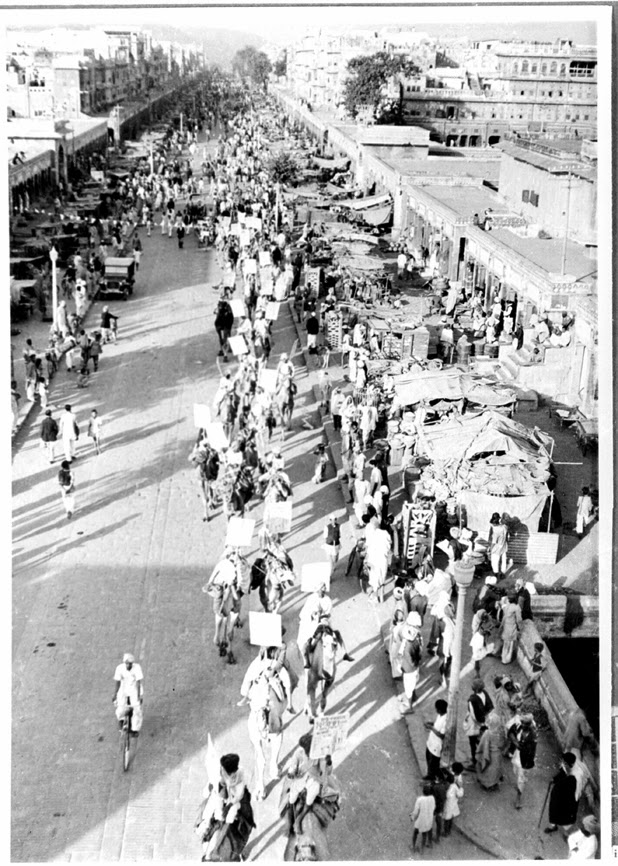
[410, 761, 464, 851]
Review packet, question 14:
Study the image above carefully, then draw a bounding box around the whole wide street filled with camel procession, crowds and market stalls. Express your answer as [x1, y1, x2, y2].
[12, 50, 598, 862]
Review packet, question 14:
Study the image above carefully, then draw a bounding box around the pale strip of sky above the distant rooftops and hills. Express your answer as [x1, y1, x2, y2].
[3, 2, 598, 44]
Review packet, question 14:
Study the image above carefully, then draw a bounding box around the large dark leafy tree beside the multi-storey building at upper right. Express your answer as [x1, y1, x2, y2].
[343, 51, 420, 123]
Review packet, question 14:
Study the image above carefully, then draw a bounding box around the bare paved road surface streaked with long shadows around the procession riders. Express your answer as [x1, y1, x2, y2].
[12, 140, 478, 861]
